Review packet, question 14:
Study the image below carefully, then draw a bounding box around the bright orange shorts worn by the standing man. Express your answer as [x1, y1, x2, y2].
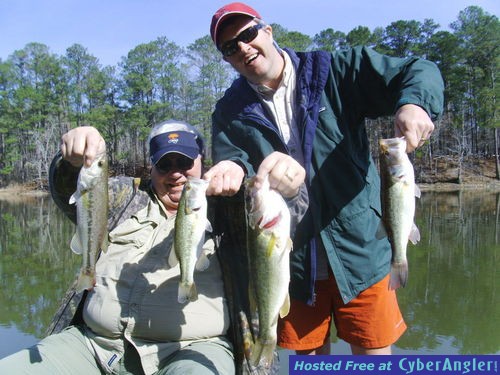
[278, 275, 406, 350]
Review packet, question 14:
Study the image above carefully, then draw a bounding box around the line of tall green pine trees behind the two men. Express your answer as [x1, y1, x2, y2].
[0, 6, 500, 186]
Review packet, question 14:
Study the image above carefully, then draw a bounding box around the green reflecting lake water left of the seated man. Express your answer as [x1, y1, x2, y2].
[0, 196, 81, 341]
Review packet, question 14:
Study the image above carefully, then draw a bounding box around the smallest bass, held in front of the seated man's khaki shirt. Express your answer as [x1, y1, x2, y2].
[169, 177, 212, 303]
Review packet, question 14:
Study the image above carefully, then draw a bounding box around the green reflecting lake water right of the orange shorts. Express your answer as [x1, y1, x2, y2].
[398, 192, 500, 354]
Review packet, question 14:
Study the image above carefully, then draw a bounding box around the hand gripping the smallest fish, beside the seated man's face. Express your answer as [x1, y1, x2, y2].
[203, 160, 245, 197]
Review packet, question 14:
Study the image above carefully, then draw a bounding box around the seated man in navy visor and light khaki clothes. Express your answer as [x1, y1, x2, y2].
[0, 121, 235, 375]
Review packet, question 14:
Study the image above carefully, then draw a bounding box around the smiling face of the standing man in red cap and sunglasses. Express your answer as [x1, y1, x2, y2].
[219, 16, 282, 84]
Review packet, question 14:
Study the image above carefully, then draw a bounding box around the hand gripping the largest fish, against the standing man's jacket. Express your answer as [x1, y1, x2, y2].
[255, 151, 306, 198]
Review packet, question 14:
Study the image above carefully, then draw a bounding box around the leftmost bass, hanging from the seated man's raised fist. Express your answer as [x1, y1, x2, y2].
[69, 151, 108, 291]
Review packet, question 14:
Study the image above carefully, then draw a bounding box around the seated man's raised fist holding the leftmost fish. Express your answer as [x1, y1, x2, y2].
[61, 126, 106, 167]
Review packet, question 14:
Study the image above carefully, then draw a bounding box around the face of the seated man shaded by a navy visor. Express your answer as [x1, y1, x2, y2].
[151, 153, 202, 211]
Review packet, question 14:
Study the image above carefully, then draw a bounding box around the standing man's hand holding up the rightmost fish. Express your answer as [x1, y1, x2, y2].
[394, 104, 434, 152]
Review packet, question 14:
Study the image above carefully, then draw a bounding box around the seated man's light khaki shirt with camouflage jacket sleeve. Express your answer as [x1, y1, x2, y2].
[50, 158, 231, 374]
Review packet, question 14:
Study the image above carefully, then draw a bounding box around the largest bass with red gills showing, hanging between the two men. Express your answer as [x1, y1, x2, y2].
[245, 179, 292, 368]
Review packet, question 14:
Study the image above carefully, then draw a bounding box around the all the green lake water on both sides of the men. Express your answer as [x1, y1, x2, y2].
[0, 191, 500, 374]
